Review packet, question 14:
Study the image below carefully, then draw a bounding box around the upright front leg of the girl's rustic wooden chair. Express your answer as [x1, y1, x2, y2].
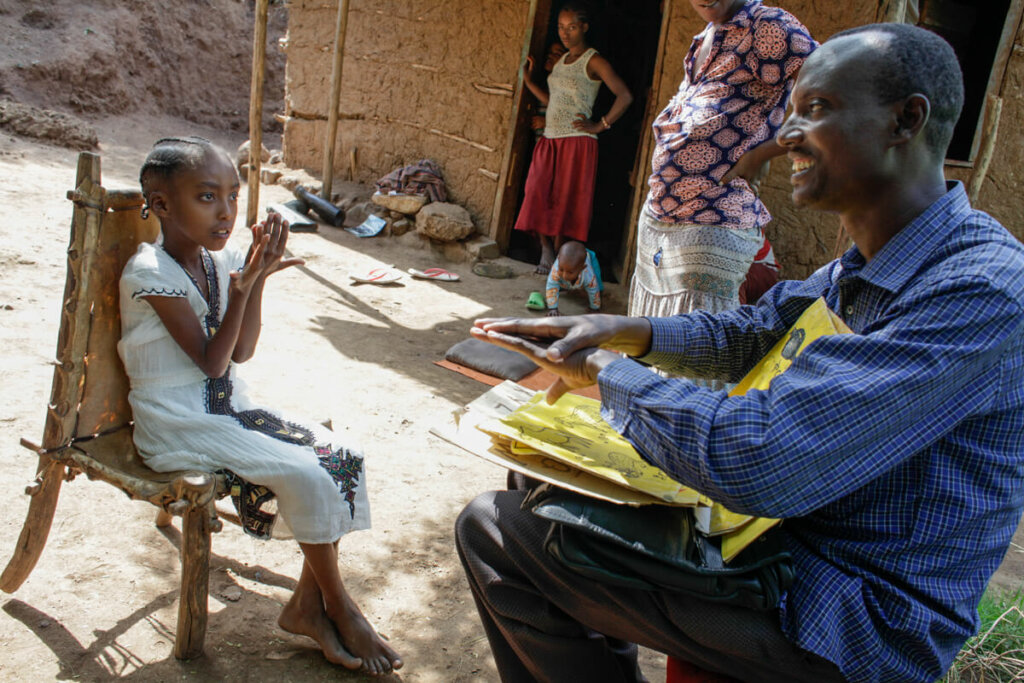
[174, 505, 210, 659]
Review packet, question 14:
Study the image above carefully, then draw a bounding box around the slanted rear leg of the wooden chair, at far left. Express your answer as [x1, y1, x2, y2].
[0, 456, 65, 593]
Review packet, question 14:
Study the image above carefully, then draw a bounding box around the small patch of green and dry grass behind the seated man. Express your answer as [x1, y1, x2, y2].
[943, 589, 1024, 683]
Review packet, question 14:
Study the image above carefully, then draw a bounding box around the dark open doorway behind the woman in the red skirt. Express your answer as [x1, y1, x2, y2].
[507, 0, 663, 282]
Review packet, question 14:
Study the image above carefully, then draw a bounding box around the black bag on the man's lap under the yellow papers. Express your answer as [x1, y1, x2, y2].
[522, 484, 793, 609]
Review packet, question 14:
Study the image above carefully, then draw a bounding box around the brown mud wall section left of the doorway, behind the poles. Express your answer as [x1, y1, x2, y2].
[284, 0, 529, 230]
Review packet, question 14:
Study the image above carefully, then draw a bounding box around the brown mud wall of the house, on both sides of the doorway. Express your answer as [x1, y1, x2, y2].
[284, 0, 1024, 278]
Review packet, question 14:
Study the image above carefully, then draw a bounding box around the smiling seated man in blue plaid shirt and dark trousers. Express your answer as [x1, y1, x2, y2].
[456, 25, 1024, 682]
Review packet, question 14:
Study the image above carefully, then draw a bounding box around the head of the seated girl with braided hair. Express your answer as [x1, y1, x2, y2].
[139, 137, 239, 249]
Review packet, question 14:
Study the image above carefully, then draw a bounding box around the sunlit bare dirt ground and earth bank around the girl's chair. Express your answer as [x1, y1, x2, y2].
[0, 0, 1024, 683]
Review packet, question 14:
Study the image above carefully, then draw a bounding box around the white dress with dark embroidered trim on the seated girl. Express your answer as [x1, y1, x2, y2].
[118, 244, 370, 543]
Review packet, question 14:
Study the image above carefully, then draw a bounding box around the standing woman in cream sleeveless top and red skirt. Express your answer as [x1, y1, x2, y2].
[515, 2, 633, 274]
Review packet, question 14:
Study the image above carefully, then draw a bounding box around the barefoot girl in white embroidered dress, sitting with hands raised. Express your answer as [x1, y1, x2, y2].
[118, 137, 401, 675]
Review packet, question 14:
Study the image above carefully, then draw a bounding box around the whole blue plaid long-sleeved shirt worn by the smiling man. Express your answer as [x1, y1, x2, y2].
[598, 185, 1024, 681]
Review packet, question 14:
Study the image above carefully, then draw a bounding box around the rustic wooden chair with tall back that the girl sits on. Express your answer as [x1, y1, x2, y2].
[0, 153, 233, 659]
